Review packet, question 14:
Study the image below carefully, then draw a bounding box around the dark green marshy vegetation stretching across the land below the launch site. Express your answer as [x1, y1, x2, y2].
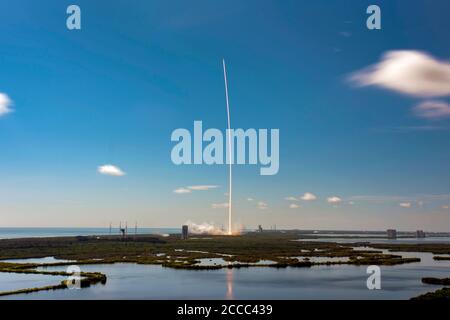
[0, 232, 436, 295]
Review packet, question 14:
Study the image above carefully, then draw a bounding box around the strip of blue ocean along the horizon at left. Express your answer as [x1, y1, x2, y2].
[0, 227, 181, 239]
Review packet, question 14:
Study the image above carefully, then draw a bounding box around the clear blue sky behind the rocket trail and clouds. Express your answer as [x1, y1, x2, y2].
[0, 0, 450, 231]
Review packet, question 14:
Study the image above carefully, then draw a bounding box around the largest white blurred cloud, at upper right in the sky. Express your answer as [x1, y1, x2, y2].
[349, 50, 450, 97]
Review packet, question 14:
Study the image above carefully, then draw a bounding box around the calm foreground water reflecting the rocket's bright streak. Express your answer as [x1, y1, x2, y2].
[0, 252, 450, 299]
